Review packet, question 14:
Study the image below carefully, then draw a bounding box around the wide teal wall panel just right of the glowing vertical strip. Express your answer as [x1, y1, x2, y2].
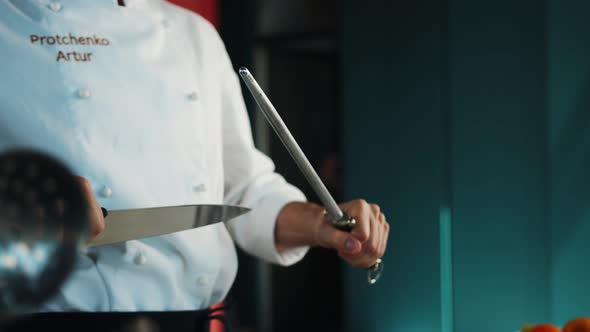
[448, 0, 549, 332]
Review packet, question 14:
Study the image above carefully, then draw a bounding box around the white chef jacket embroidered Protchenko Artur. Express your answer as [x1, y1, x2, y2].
[0, 0, 308, 311]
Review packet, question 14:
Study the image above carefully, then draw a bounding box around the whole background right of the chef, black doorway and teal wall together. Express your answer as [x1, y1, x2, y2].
[215, 0, 590, 332]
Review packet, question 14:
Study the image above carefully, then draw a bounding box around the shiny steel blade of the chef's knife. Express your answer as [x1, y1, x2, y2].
[89, 205, 250, 247]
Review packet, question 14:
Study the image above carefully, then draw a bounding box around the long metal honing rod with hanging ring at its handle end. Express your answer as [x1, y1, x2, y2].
[239, 67, 384, 284]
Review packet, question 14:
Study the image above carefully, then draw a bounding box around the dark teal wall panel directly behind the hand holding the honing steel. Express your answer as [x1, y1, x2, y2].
[341, 0, 447, 332]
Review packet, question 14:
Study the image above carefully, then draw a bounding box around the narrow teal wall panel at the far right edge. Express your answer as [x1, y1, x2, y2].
[547, 0, 590, 324]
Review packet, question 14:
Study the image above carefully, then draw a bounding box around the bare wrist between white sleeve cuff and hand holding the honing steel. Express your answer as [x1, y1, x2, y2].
[275, 202, 324, 252]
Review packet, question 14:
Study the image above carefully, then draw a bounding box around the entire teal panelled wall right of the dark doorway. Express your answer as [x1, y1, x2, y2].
[341, 0, 590, 332]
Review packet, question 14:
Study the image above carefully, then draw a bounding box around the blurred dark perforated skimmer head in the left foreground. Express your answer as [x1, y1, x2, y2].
[0, 151, 89, 316]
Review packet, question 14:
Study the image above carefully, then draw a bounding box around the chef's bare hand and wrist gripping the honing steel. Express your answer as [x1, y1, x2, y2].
[275, 199, 389, 268]
